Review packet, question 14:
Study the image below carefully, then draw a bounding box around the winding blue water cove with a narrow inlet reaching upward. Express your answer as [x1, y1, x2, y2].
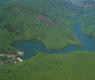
[13, 17, 95, 60]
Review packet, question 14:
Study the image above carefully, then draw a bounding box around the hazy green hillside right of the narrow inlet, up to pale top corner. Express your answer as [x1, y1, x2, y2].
[66, 0, 95, 37]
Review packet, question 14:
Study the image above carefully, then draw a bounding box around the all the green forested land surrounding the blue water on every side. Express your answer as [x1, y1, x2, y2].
[0, 0, 95, 80]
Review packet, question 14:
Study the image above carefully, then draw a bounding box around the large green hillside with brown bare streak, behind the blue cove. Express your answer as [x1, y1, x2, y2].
[0, 0, 81, 58]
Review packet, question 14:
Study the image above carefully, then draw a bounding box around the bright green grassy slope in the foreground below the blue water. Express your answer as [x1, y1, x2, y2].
[0, 51, 95, 80]
